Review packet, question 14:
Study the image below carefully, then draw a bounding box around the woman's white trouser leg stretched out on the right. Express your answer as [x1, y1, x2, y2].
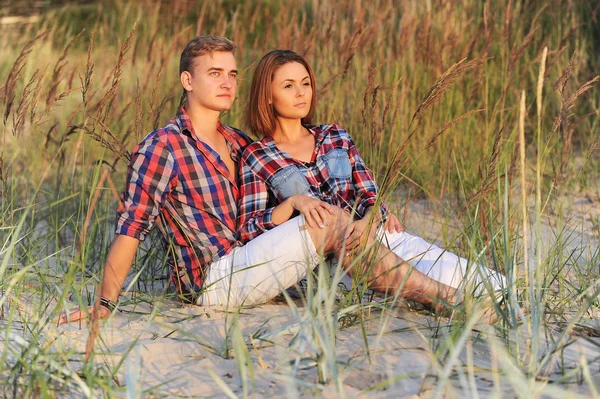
[378, 230, 506, 296]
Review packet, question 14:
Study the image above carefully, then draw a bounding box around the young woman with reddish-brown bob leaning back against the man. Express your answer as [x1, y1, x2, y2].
[238, 50, 506, 295]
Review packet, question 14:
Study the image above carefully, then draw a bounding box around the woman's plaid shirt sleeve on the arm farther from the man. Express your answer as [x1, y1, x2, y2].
[346, 133, 388, 220]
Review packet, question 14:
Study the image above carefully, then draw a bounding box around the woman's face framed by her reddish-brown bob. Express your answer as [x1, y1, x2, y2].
[271, 62, 312, 119]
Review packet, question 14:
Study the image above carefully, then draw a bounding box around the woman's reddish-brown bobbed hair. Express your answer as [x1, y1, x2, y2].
[244, 50, 317, 136]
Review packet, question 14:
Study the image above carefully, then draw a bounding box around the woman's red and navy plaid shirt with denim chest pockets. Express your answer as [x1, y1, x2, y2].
[238, 125, 387, 243]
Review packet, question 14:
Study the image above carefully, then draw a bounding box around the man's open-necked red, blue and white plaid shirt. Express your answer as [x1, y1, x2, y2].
[116, 107, 251, 294]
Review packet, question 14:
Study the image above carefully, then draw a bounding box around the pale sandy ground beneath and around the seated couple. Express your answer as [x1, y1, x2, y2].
[4, 192, 600, 398]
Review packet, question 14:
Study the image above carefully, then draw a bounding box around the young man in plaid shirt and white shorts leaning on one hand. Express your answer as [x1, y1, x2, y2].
[59, 36, 454, 323]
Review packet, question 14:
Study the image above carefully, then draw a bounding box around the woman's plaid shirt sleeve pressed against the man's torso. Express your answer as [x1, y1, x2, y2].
[238, 152, 277, 243]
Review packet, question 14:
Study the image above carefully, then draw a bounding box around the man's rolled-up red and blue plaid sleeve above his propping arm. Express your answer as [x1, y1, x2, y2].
[116, 140, 177, 241]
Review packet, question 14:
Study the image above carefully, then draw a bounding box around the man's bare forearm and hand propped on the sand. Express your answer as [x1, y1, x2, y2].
[58, 235, 140, 324]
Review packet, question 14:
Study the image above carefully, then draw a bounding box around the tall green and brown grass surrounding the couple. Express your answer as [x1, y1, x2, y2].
[0, 0, 600, 397]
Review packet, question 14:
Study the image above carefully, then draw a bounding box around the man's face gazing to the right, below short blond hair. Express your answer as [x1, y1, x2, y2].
[181, 51, 238, 111]
